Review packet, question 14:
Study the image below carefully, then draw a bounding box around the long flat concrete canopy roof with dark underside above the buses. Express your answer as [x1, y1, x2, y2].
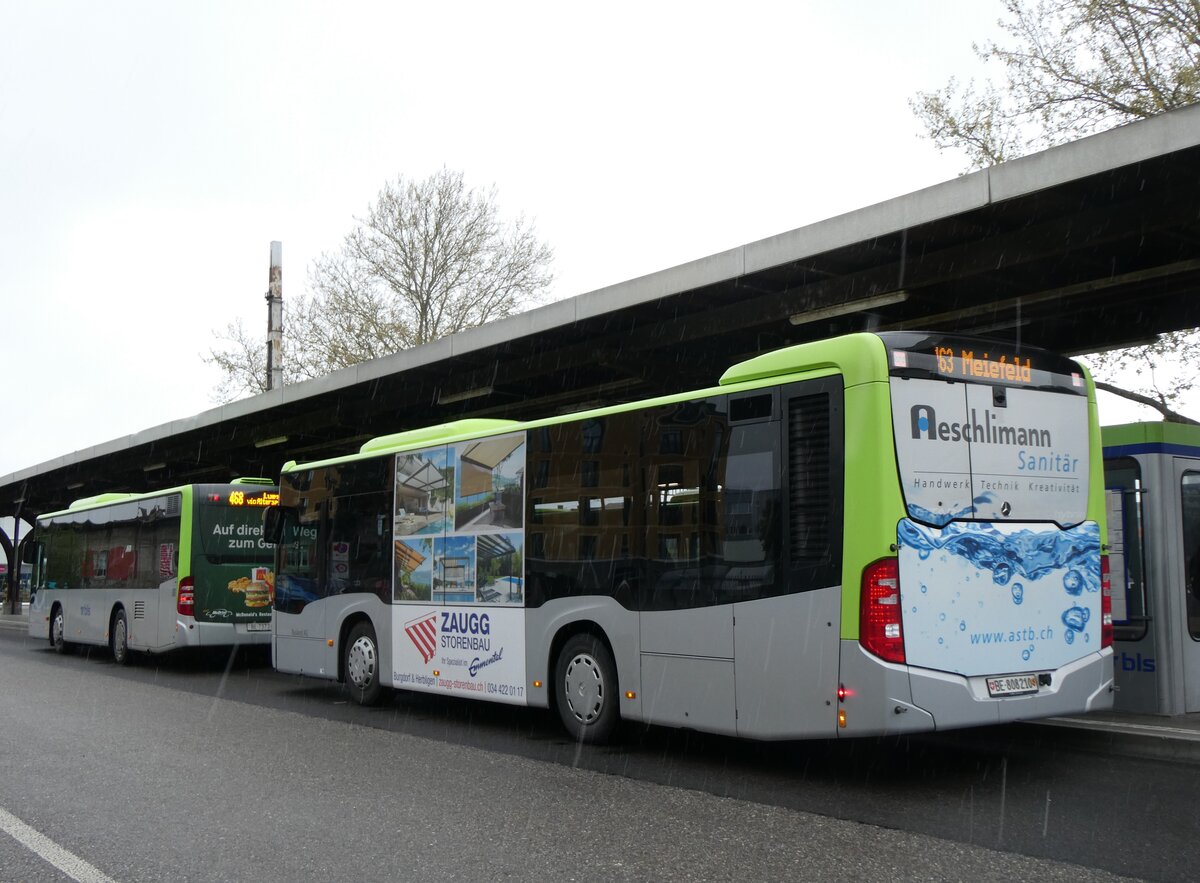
[7, 106, 1200, 517]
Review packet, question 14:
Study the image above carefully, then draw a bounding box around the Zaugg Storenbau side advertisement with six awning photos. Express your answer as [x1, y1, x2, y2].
[391, 432, 528, 704]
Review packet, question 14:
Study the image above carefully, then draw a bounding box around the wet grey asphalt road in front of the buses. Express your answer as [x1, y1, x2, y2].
[0, 631, 1185, 882]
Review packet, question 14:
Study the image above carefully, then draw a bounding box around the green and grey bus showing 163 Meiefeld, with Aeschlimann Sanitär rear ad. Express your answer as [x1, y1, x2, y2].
[266, 332, 1112, 740]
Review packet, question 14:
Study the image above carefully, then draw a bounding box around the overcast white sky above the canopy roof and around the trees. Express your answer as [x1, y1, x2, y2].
[0, 0, 1171, 476]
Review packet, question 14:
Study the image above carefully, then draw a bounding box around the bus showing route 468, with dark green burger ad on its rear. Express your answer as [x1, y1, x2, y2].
[25, 479, 278, 663]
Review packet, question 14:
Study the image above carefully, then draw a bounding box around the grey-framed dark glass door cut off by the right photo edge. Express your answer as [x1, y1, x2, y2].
[1165, 457, 1200, 713]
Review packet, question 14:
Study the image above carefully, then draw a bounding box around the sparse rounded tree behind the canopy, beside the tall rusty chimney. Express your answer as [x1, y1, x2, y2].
[205, 169, 553, 401]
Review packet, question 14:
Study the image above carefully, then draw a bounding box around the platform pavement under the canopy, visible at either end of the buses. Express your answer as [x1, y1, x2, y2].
[0, 603, 1200, 764]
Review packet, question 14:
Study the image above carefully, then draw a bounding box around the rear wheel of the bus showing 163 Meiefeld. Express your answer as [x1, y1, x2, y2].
[554, 635, 620, 744]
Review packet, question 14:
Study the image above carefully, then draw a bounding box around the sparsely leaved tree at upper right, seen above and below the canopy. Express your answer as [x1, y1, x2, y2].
[910, 0, 1200, 422]
